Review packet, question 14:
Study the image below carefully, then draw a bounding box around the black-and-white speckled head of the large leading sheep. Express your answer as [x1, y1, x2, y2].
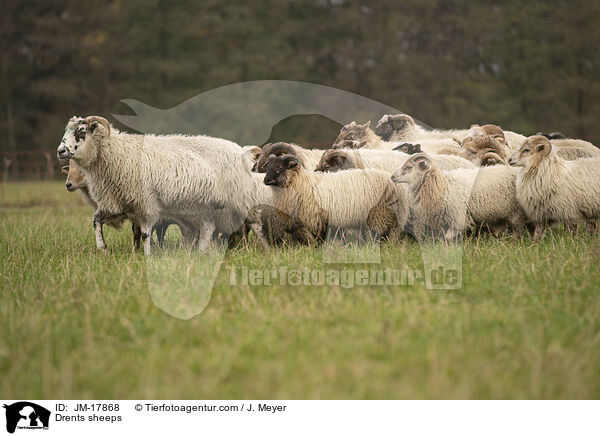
[56, 116, 110, 160]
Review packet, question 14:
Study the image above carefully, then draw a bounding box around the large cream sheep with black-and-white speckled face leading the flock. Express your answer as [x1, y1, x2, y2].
[57, 116, 268, 255]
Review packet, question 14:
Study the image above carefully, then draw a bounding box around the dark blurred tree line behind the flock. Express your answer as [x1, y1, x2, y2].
[0, 0, 600, 151]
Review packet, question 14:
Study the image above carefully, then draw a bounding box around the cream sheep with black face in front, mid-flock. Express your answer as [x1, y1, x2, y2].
[264, 154, 408, 243]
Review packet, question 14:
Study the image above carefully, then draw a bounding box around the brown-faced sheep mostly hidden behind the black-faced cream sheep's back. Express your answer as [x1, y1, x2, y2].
[315, 148, 475, 173]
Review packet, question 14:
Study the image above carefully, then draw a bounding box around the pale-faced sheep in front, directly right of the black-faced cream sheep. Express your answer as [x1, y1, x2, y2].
[392, 154, 525, 241]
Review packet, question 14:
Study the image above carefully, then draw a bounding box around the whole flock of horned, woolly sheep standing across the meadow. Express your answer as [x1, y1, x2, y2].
[57, 114, 600, 254]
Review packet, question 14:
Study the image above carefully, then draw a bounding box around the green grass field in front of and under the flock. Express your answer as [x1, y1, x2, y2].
[0, 182, 600, 399]
